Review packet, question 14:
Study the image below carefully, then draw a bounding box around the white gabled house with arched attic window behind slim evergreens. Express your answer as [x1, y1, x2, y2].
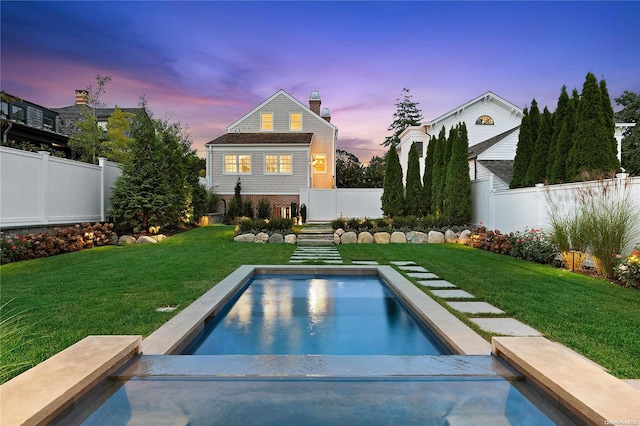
[397, 92, 523, 190]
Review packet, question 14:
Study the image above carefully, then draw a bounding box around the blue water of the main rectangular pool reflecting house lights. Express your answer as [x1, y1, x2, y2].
[183, 275, 450, 355]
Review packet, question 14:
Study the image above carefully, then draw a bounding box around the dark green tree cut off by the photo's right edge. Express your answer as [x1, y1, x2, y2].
[616, 90, 640, 176]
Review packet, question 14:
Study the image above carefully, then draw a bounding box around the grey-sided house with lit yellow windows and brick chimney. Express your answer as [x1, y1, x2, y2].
[205, 90, 338, 217]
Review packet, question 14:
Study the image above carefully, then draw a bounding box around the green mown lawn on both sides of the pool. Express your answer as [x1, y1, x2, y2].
[0, 226, 640, 378]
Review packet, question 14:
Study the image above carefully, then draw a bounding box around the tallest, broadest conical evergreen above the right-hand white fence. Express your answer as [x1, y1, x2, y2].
[567, 73, 620, 180]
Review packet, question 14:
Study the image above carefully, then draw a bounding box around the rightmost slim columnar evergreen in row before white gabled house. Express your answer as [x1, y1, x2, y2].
[443, 123, 472, 225]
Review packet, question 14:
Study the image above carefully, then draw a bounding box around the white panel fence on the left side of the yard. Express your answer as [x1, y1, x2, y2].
[0, 147, 121, 228]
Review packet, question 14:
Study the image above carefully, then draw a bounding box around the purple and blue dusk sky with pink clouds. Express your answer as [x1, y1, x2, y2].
[0, 0, 640, 161]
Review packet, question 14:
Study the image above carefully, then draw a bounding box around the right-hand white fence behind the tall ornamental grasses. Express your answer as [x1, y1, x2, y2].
[471, 177, 640, 242]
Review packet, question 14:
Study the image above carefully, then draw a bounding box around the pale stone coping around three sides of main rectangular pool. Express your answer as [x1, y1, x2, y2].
[142, 265, 491, 355]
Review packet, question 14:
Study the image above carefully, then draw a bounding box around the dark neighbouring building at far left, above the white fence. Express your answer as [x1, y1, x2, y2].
[1, 92, 71, 157]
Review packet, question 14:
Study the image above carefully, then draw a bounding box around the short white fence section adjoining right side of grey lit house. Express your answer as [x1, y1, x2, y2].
[300, 188, 382, 222]
